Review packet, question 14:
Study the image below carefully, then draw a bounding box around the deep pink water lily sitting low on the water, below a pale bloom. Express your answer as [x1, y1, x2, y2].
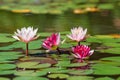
[72, 45, 94, 60]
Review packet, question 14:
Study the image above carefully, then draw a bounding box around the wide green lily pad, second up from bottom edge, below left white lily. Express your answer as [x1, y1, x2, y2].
[14, 70, 47, 76]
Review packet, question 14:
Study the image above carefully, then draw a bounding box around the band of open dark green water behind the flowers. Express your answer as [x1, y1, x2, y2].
[0, 9, 120, 35]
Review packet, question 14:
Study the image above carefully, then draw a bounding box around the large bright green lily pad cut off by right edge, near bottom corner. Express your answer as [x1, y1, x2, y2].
[92, 64, 120, 75]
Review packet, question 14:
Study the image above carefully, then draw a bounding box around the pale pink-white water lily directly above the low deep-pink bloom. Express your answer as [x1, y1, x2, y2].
[67, 27, 87, 43]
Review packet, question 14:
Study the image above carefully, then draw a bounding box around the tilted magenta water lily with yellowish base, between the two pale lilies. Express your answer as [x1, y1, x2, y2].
[42, 33, 60, 50]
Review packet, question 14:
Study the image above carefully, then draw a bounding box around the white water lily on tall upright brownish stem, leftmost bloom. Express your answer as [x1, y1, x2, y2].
[12, 27, 39, 56]
